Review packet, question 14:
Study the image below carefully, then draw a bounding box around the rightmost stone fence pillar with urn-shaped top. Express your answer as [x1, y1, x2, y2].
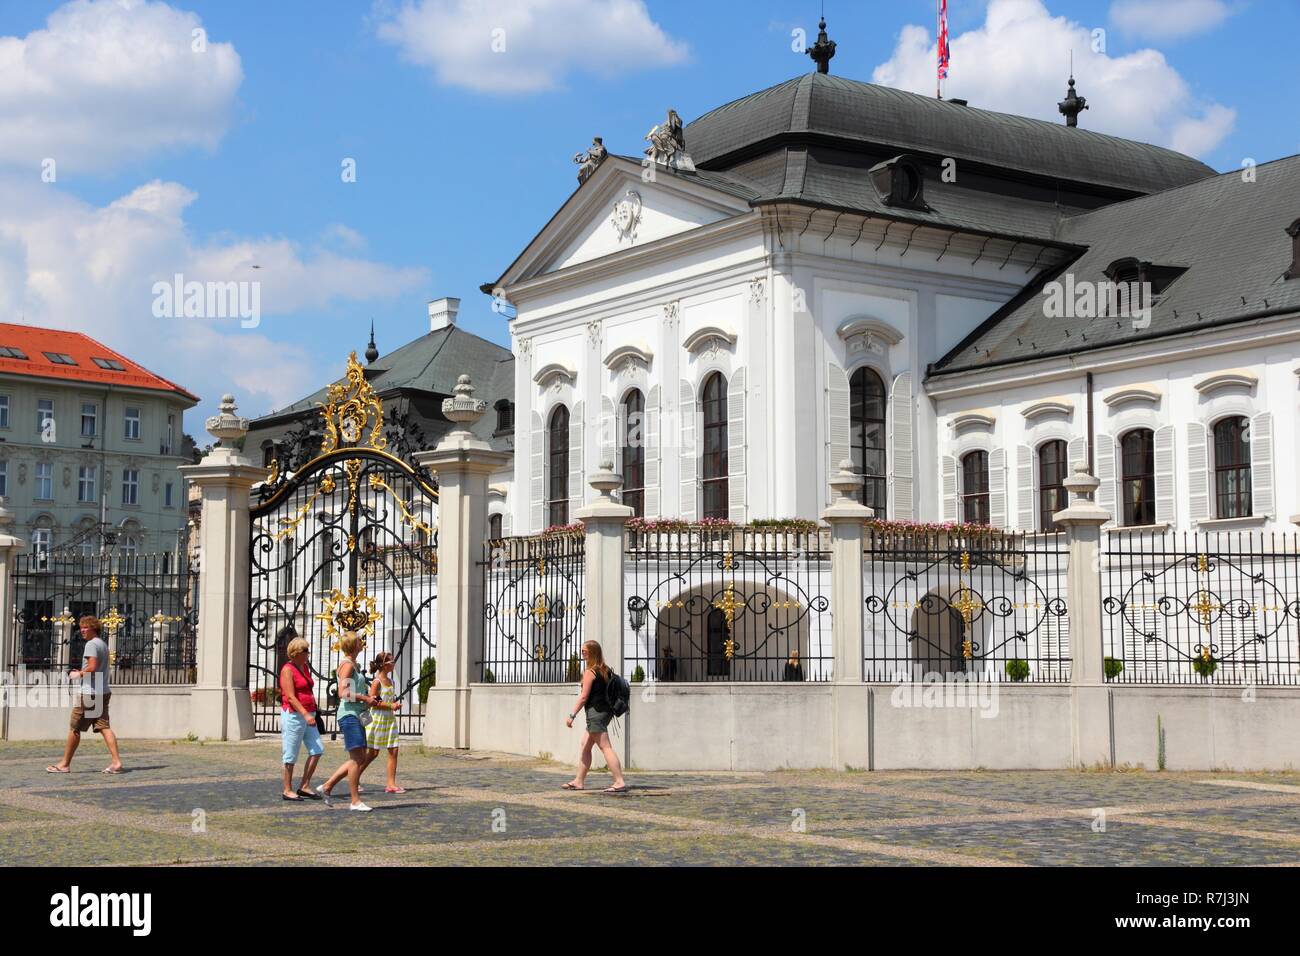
[1053, 462, 1112, 766]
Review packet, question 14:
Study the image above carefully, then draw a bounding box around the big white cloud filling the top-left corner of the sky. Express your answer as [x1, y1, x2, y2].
[0, 0, 243, 174]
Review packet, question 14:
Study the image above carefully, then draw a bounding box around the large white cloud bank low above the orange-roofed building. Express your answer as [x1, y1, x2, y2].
[0, 174, 428, 421]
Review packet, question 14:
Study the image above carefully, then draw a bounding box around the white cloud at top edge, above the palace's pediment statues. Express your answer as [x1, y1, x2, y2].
[378, 0, 686, 94]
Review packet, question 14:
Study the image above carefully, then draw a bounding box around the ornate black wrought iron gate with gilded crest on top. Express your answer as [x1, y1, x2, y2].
[248, 352, 438, 734]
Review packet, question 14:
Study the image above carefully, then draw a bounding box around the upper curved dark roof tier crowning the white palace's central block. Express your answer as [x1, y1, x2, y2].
[685, 73, 1214, 194]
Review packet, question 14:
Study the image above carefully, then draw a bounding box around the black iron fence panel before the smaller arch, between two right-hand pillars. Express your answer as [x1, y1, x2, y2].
[863, 528, 1070, 683]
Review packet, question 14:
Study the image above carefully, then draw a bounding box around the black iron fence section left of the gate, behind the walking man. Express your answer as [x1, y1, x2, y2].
[10, 551, 199, 685]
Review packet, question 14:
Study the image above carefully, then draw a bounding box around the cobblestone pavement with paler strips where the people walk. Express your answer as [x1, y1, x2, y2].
[0, 735, 1300, 866]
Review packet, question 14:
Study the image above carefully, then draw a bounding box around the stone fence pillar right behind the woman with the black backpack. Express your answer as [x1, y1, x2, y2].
[573, 462, 632, 680]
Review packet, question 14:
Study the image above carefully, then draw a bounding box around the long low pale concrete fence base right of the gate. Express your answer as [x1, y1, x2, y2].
[471, 683, 1300, 770]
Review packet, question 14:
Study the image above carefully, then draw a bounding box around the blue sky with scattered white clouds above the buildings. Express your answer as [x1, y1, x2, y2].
[0, 0, 1300, 432]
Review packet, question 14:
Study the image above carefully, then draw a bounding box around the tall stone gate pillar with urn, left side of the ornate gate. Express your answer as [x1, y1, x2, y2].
[181, 395, 267, 740]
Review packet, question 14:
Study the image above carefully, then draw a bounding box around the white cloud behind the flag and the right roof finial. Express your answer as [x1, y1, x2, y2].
[872, 0, 1236, 155]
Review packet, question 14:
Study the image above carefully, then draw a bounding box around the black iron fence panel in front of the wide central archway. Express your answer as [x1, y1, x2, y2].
[623, 525, 833, 682]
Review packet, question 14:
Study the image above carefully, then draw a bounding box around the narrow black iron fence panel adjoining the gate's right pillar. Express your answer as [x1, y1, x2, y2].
[480, 531, 586, 684]
